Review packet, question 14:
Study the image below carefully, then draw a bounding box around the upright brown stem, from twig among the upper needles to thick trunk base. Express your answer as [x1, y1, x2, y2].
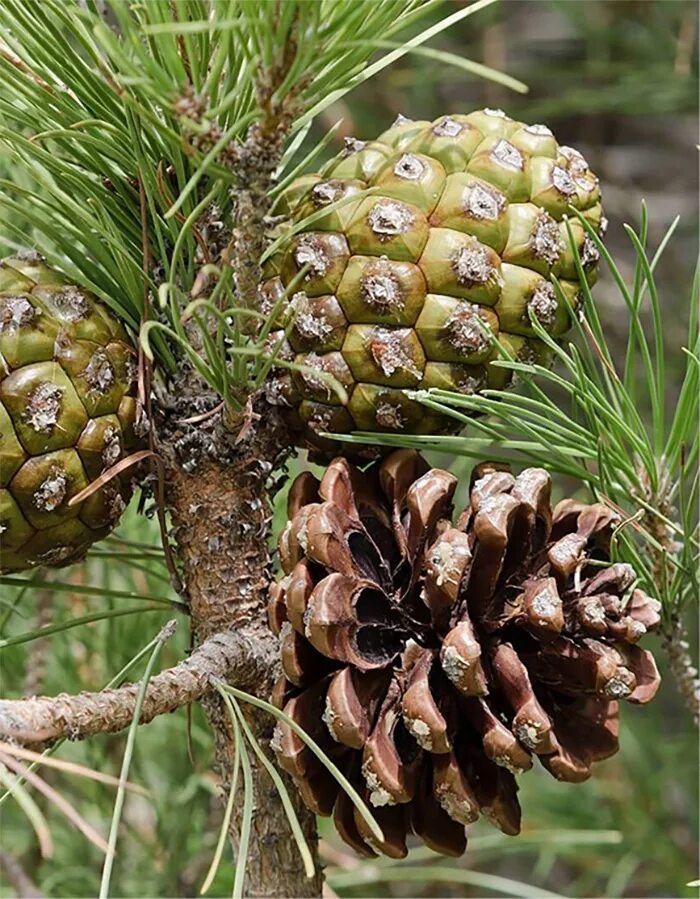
[158, 24, 322, 897]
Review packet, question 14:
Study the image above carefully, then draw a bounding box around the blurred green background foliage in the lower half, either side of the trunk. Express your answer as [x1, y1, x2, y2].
[0, 500, 697, 899]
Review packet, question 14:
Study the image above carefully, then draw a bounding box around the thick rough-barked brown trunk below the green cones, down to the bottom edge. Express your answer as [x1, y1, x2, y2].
[167, 422, 322, 897]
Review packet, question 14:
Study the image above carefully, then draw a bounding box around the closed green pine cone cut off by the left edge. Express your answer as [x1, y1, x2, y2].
[0, 253, 137, 572]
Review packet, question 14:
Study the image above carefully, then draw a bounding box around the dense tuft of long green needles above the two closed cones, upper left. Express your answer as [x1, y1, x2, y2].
[0, 0, 504, 407]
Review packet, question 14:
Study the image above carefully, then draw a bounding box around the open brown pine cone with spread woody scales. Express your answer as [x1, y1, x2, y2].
[269, 450, 660, 857]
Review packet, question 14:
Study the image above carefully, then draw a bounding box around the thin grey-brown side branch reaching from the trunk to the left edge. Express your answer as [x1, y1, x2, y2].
[0, 632, 277, 744]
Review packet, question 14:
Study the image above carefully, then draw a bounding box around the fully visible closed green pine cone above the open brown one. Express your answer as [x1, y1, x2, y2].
[260, 109, 605, 452]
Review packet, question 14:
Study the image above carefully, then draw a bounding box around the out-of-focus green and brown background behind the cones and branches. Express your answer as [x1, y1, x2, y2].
[0, 0, 698, 897]
